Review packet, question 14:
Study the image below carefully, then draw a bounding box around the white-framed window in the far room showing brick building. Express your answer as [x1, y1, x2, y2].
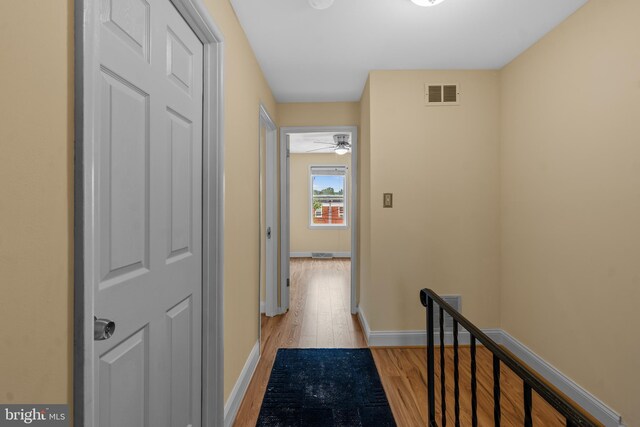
[309, 166, 347, 228]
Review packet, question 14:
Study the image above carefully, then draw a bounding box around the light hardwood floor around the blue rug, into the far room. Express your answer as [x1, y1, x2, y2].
[234, 258, 576, 427]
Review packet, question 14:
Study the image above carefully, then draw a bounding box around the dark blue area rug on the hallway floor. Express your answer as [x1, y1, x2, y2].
[256, 348, 396, 427]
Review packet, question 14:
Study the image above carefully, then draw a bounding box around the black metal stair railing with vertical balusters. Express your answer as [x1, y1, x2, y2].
[420, 289, 597, 427]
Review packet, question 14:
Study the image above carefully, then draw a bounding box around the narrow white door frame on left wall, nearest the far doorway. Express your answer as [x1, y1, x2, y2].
[258, 103, 279, 317]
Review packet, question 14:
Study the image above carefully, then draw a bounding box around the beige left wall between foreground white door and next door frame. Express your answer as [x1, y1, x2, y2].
[204, 0, 277, 400]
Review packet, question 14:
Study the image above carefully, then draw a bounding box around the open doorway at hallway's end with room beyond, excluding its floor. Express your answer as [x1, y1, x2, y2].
[280, 126, 358, 314]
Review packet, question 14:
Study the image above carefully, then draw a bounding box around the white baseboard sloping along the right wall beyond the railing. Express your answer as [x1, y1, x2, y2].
[501, 330, 624, 427]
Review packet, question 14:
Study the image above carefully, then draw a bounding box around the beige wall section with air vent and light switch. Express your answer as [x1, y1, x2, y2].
[360, 71, 499, 330]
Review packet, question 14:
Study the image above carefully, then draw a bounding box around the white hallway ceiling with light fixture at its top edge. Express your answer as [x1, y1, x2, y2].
[231, 0, 587, 102]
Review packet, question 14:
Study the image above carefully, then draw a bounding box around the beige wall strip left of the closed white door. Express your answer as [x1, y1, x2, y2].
[0, 0, 73, 403]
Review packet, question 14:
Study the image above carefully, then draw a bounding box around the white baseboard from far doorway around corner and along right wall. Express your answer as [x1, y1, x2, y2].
[358, 307, 624, 427]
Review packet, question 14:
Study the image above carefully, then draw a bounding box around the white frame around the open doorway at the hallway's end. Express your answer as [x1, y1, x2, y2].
[280, 126, 359, 314]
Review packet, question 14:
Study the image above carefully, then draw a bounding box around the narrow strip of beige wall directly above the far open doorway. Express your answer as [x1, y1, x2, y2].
[278, 102, 360, 126]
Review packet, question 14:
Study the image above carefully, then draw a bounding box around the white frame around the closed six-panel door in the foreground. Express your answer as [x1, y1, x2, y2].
[73, 0, 224, 427]
